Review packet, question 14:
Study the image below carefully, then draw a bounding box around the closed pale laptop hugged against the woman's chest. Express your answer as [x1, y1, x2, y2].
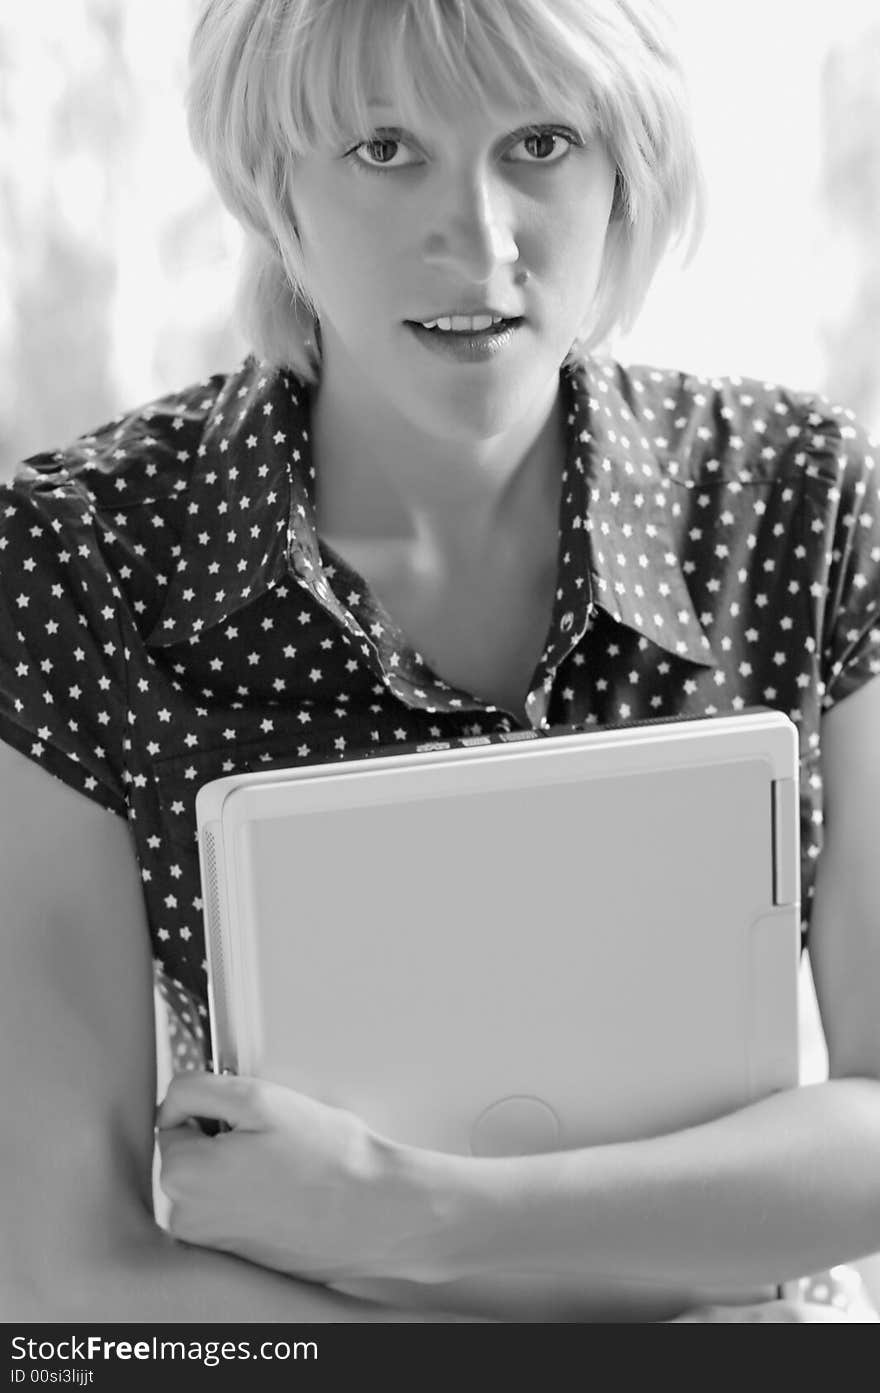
[196, 710, 799, 1319]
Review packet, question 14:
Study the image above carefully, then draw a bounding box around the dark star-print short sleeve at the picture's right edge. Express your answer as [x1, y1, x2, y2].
[812, 412, 880, 708]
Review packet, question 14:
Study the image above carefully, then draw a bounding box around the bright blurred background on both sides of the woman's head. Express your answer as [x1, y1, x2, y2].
[0, 0, 880, 478]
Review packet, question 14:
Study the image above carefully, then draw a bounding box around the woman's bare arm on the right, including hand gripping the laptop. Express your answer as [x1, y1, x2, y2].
[151, 683, 880, 1298]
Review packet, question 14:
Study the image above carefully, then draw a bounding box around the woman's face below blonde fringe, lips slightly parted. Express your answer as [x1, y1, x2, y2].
[291, 89, 615, 440]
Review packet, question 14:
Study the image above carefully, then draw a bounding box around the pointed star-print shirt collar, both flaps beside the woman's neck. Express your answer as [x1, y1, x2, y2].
[148, 358, 716, 666]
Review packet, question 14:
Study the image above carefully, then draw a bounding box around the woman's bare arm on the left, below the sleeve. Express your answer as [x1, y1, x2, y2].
[0, 742, 473, 1322]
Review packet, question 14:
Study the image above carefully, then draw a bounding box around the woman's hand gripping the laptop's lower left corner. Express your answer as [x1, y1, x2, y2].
[157, 1073, 430, 1282]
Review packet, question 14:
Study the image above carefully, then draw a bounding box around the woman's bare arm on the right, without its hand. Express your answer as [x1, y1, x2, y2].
[389, 681, 880, 1284]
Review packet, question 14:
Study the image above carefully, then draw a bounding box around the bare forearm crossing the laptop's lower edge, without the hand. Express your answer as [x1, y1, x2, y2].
[401, 1078, 880, 1286]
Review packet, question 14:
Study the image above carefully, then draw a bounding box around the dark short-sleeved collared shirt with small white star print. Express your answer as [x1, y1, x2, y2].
[0, 358, 880, 1067]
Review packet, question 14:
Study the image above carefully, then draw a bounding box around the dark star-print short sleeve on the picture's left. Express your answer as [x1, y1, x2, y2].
[0, 465, 128, 816]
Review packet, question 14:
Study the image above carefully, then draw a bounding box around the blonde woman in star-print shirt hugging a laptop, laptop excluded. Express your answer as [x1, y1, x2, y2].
[0, 0, 880, 1321]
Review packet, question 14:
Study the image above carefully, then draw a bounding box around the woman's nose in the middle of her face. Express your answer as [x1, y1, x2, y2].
[425, 180, 519, 284]
